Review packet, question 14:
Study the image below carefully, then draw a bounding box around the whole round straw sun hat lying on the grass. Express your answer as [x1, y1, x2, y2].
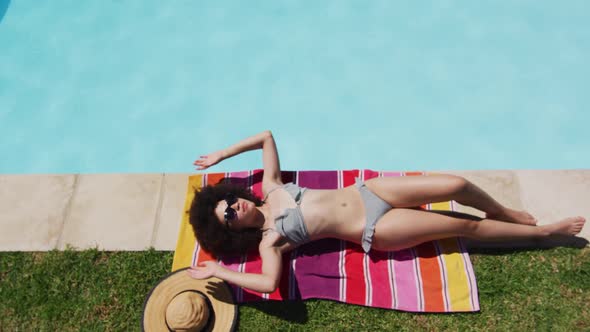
[141, 268, 238, 332]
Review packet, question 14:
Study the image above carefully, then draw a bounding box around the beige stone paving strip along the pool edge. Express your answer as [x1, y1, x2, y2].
[0, 169, 590, 251]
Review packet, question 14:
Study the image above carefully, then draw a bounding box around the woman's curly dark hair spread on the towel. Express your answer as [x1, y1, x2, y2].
[189, 183, 262, 256]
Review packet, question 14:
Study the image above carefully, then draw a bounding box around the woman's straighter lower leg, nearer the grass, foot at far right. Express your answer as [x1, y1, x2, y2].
[373, 209, 586, 250]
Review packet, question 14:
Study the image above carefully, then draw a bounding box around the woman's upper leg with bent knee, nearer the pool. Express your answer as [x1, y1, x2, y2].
[365, 174, 537, 225]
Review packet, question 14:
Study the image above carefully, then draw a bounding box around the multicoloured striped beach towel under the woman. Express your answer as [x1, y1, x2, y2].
[172, 170, 479, 312]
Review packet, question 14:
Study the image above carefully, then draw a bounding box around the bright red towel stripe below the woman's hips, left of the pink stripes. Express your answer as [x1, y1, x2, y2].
[344, 242, 367, 305]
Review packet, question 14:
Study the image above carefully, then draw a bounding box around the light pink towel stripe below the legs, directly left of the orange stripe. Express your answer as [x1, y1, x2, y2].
[393, 249, 420, 311]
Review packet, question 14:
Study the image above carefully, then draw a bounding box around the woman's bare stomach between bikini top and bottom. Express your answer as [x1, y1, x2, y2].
[301, 186, 365, 243]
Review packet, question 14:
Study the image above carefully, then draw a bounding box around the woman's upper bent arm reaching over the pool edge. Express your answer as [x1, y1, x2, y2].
[194, 130, 282, 189]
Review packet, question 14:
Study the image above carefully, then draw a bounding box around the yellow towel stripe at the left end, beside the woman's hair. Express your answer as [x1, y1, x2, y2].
[172, 174, 203, 271]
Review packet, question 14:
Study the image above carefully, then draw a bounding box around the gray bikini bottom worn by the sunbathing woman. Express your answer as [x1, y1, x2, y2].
[354, 178, 393, 252]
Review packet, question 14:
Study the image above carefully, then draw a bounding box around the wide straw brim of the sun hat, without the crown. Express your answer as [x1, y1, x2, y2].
[141, 268, 238, 332]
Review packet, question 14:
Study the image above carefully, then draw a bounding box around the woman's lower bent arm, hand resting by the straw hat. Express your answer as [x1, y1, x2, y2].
[187, 232, 282, 293]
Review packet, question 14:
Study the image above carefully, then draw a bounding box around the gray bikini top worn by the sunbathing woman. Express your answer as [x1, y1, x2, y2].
[264, 182, 310, 245]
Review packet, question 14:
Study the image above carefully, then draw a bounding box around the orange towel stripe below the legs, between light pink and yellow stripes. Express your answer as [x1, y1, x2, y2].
[416, 242, 445, 312]
